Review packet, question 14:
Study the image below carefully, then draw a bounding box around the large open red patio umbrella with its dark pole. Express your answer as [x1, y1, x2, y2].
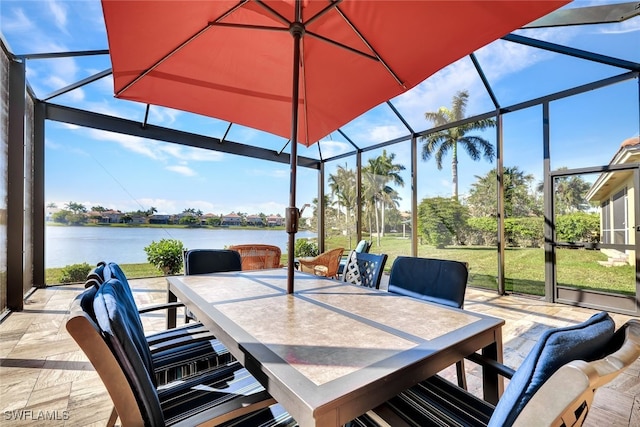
[102, 0, 569, 292]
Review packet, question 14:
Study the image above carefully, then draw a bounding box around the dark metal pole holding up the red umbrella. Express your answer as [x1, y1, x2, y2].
[286, 0, 304, 294]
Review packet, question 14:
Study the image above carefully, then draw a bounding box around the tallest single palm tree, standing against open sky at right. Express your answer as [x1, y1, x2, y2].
[420, 90, 496, 200]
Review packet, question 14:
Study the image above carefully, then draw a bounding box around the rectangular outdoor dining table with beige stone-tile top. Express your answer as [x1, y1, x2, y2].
[167, 269, 504, 426]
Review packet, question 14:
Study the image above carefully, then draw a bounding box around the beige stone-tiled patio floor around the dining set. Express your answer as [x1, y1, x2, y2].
[0, 278, 640, 427]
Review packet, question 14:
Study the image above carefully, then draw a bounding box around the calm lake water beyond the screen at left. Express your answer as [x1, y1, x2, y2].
[45, 227, 316, 268]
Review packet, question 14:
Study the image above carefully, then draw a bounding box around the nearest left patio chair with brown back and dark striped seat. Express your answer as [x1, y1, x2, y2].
[66, 278, 275, 426]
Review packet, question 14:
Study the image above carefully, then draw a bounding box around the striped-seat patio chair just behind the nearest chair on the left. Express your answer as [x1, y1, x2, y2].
[85, 262, 235, 385]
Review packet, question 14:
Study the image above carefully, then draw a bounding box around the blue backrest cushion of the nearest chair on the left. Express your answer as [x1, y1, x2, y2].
[93, 278, 164, 425]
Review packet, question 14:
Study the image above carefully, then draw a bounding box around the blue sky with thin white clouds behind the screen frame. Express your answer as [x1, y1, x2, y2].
[0, 0, 640, 216]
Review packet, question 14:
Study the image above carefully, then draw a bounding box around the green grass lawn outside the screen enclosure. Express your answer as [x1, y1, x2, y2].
[46, 235, 635, 295]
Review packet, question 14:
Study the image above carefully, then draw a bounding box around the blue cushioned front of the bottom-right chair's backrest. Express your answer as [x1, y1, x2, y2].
[488, 312, 615, 427]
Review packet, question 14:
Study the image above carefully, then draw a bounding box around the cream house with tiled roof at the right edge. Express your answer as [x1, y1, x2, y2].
[586, 137, 640, 265]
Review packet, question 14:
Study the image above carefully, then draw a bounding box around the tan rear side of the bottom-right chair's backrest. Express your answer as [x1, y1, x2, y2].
[514, 319, 640, 426]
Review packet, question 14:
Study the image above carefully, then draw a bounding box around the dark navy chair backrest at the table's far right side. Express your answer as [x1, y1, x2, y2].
[388, 256, 469, 308]
